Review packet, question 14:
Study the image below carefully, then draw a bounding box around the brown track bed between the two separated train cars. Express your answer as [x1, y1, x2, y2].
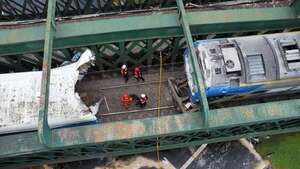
[78, 68, 184, 123]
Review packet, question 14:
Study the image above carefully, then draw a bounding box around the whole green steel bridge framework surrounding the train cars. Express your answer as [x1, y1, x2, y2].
[0, 0, 300, 168]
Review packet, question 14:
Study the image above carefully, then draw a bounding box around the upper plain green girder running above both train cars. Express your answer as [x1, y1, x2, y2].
[0, 7, 300, 56]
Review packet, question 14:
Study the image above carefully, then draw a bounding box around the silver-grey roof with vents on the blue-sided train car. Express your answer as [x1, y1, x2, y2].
[189, 32, 300, 87]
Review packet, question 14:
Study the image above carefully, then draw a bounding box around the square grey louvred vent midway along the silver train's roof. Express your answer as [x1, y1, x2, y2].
[247, 54, 266, 76]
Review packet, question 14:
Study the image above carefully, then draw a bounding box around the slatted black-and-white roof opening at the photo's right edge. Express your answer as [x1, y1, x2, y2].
[279, 40, 300, 70]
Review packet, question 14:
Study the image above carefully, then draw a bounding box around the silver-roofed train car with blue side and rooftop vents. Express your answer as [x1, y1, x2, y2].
[184, 32, 300, 103]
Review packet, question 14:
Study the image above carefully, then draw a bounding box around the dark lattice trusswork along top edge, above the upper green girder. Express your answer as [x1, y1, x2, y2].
[0, 0, 286, 22]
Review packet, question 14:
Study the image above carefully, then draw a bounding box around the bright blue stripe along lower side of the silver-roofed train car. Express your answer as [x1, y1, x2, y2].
[191, 84, 264, 102]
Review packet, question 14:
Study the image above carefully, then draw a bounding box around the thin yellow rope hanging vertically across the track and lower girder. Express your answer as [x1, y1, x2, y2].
[156, 52, 163, 168]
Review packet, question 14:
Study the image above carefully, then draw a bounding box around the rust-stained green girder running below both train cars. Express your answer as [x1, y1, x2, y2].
[0, 100, 300, 168]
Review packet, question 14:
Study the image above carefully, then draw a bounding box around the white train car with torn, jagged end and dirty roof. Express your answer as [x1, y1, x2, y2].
[0, 50, 99, 134]
